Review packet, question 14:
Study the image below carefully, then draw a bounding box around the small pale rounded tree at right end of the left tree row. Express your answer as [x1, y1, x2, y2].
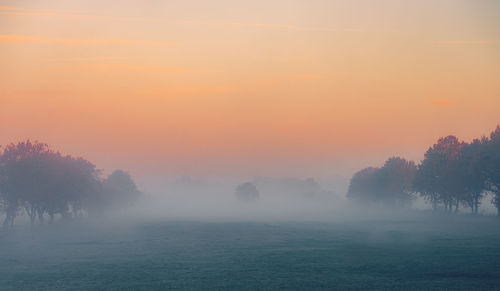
[102, 170, 141, 210]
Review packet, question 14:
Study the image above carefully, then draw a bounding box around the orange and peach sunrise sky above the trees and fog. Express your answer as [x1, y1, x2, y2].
[0, 0, 500, 179]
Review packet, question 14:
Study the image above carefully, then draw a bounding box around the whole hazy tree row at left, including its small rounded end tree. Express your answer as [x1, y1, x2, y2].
[0, 140, 140, 231]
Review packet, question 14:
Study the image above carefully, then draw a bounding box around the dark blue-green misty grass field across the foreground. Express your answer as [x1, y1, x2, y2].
[0, 216, 500, 290]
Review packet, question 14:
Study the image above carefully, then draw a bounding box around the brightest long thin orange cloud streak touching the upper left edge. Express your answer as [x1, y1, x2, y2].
[0, 35, 176, 47]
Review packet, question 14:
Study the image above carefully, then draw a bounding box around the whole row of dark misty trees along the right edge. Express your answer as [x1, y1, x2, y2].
[347, 125, 500, 216]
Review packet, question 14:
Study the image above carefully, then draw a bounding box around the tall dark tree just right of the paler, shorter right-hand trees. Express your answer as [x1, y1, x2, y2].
[414, 135, 464, 212]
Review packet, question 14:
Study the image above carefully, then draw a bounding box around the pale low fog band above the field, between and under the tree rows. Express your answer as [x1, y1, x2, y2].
[4, 177, 496, 228]
